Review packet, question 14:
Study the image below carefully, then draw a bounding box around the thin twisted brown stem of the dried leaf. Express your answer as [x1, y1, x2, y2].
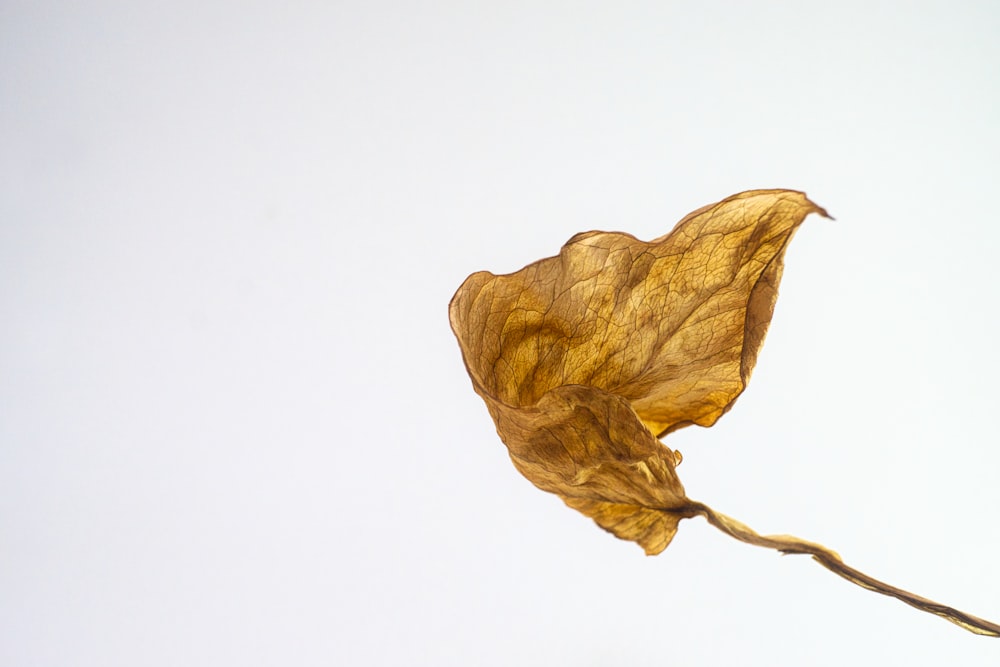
[681, 502, 1000, 637]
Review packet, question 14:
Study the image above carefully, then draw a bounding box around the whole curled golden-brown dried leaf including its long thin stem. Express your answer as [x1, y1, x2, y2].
[450, 190, 1000, 636]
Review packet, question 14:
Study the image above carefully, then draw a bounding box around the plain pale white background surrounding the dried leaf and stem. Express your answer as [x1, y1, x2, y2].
[0, 0, 1000, 667]
